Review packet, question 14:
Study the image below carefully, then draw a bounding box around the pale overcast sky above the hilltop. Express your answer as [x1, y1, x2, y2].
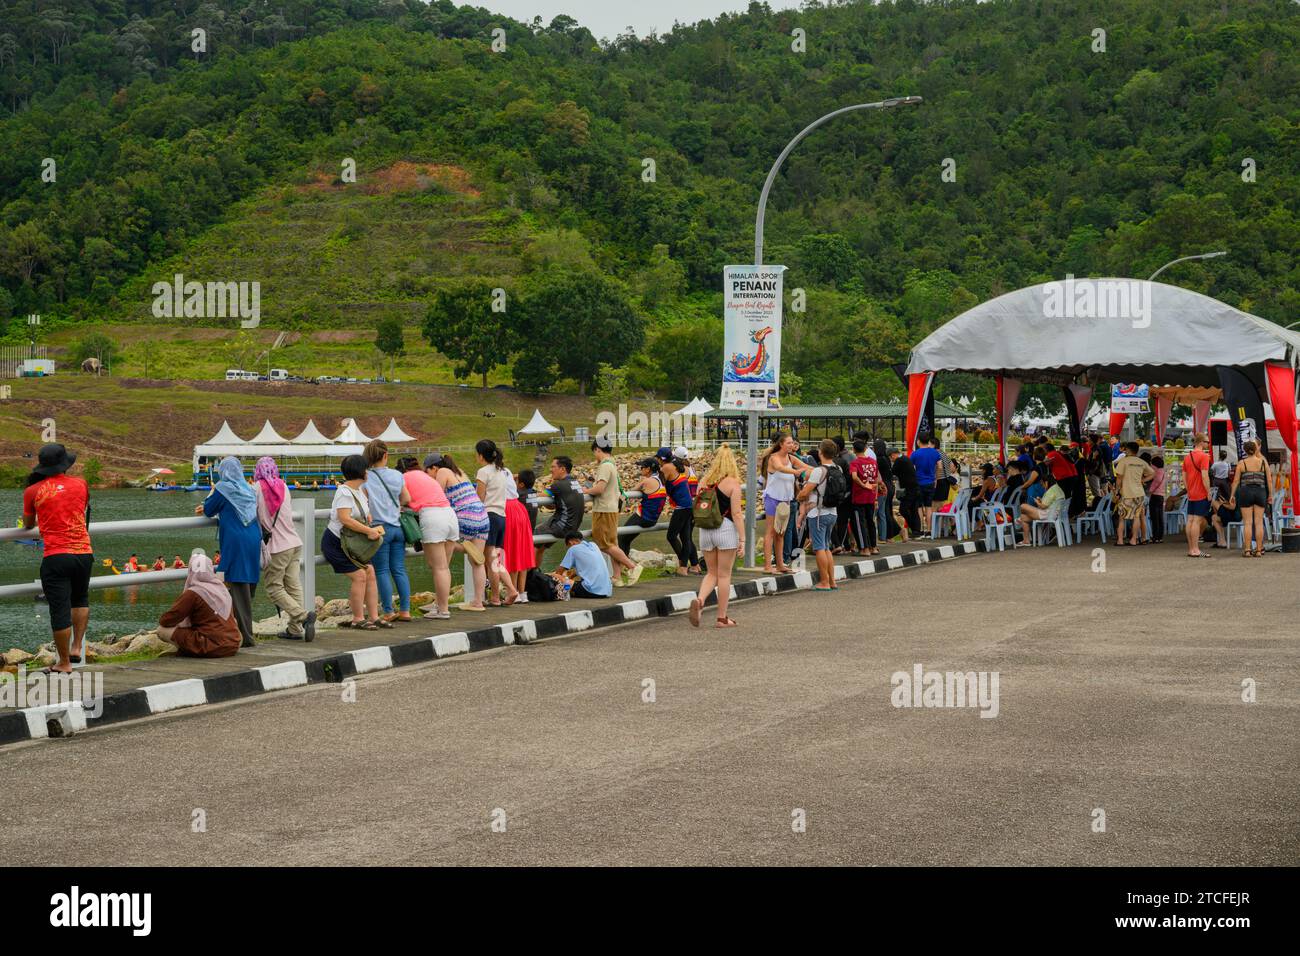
[483, 0, 759, 40]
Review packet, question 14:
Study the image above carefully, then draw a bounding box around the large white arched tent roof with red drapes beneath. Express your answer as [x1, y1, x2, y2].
[907, 278, 1300, 385]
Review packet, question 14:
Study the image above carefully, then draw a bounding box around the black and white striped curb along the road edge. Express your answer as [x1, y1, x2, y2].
[0, 541, 985, 745]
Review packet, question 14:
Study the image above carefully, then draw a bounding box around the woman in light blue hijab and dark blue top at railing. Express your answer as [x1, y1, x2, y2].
[194, 455, 261, 648]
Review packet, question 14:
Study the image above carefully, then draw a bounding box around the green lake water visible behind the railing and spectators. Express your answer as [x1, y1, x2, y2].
[0, 488, 457, 650]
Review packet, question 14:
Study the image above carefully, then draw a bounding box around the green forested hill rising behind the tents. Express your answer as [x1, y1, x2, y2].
[0, 0, 1300, 401]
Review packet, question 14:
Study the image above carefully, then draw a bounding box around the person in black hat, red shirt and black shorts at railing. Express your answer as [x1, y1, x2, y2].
[22, 445, 95, 674]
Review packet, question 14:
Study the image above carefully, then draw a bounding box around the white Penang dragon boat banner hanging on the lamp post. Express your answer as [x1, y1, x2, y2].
[719, 265, 785, 411]
